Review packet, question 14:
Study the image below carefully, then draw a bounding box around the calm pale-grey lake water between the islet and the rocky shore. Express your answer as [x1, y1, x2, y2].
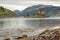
[0, 19, 60, 37]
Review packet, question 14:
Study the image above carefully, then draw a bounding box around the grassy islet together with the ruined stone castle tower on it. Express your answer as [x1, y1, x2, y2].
[26, 8, 48, 18]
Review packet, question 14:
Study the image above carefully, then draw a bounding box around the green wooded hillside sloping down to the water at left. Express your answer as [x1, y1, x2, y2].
[0, 7, 17, 18]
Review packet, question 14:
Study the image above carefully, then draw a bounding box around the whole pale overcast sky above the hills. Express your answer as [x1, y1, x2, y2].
[0, 0, 60, 11]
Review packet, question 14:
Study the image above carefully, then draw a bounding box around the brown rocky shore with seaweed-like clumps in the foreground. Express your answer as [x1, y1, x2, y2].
[4, 28, 60, 40]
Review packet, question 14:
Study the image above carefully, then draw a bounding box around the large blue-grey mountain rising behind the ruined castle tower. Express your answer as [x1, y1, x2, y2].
[20, 4, 60, 17]
